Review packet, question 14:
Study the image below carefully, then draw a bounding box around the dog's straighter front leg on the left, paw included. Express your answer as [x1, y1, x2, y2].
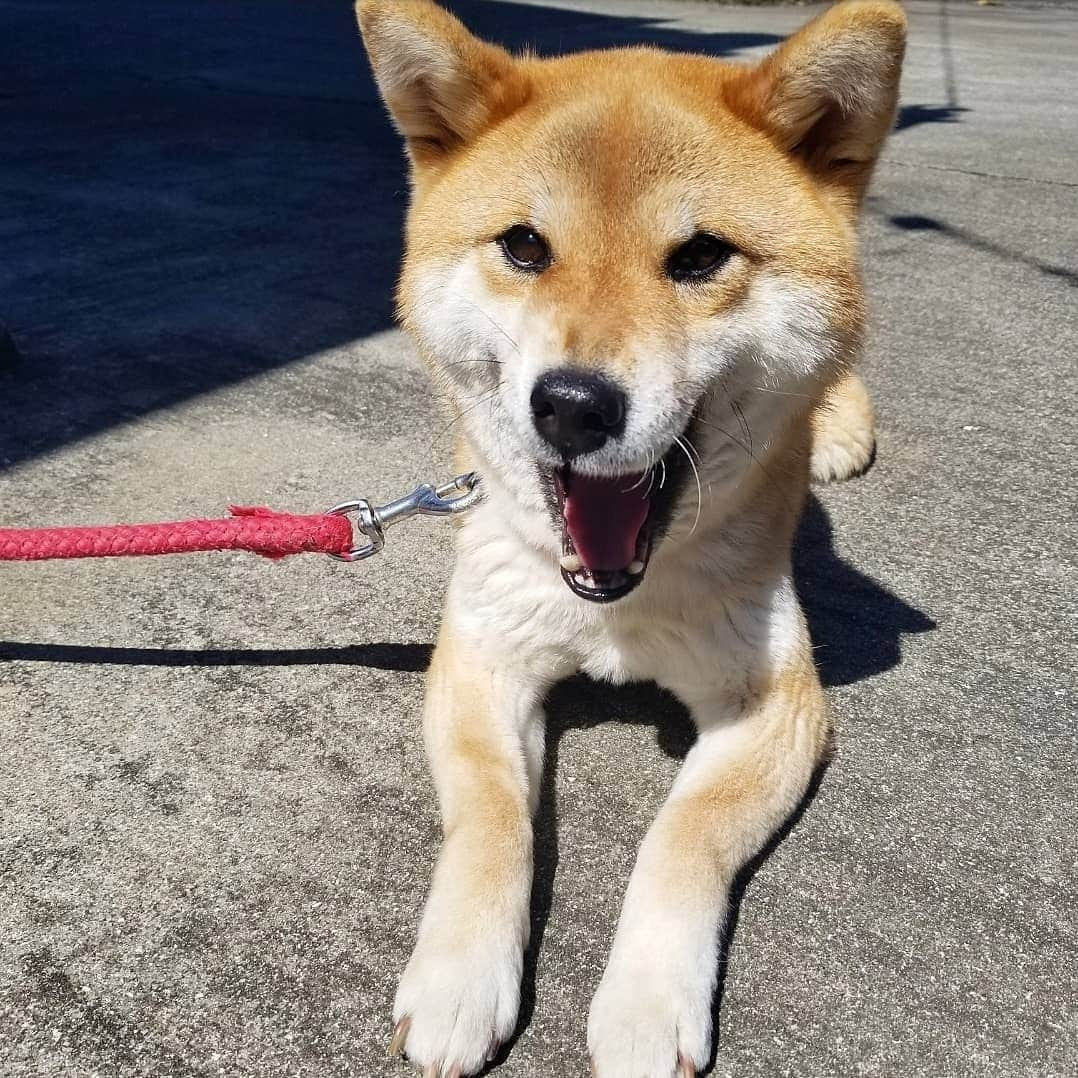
[390, 619, 548, 1078]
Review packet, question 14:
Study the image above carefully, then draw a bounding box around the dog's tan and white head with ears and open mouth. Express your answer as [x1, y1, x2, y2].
[358, 0, 904, 600]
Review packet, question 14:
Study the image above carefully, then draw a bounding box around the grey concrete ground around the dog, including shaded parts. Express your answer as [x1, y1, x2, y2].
[0, 0, 1078, 1078]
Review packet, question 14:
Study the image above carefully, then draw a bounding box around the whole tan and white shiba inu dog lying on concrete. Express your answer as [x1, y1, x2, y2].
[358, 0, 906, 1078]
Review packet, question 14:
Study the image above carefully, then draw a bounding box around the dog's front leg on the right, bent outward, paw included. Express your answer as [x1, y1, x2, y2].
[588, 659, 828, 1078]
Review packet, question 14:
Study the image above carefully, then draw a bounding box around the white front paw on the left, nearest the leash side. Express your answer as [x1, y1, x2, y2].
[389, 926, 523, 1078]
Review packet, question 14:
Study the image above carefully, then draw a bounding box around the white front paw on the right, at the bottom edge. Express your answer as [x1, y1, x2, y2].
[588, 965, 711, 1078]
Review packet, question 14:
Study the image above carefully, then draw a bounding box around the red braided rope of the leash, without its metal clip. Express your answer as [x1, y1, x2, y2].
[0, 506, 353, 562]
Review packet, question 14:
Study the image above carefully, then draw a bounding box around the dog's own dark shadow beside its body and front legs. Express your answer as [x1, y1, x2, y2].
[504, 496, 936, 1063]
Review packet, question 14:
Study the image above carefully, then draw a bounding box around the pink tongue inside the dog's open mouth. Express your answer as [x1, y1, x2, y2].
[563, 475, 648, 572]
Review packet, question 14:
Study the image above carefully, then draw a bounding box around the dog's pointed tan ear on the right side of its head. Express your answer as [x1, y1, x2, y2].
[731, 0, 906, 205]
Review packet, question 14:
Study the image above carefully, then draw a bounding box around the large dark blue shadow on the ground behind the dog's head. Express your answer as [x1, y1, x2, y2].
[0, 0, 776, 470]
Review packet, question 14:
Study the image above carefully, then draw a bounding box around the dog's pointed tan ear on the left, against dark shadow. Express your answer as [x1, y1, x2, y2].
[356, 0, 526, 165]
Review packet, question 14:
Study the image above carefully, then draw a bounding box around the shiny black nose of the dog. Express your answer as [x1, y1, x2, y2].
[531, 371, 625, 460]
